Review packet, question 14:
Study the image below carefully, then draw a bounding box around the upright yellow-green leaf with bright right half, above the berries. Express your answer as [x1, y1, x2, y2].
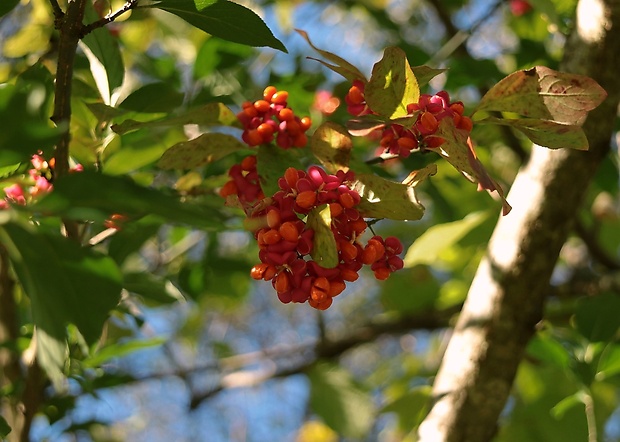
[364, 47, 420, 118]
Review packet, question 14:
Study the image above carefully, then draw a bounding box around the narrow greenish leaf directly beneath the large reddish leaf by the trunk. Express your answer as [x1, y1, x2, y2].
[476, 117, 589, 150]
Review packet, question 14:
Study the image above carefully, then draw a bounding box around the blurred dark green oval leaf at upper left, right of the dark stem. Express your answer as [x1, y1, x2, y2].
[119, 82, 184, 113]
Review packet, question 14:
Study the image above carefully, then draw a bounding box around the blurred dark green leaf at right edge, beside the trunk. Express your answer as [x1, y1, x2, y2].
[575, 293, 620, 342]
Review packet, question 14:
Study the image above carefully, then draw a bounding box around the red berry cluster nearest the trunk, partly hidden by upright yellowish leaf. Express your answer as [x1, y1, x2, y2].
[345, 80, 473, 158]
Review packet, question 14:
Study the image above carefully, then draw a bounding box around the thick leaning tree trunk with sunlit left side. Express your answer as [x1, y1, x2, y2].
[419, 0, 620, 442]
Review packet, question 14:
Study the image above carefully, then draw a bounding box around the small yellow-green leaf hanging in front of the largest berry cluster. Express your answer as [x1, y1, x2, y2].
[306, 205, 340, 269]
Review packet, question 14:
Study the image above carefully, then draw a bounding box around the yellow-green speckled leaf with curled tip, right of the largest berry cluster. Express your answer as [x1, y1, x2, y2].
[353, 169, 437, 221]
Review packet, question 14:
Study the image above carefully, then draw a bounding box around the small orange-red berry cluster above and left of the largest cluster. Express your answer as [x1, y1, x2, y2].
[237, 86, 312, 149]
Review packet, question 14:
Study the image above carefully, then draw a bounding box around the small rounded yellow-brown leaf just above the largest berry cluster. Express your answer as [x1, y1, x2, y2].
[310, 122, 353, 173]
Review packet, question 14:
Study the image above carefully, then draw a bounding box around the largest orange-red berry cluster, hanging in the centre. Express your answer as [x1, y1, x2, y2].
[251, 166, 403, 310]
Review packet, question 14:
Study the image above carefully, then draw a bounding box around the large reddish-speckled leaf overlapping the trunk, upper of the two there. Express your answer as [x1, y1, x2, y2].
[476, 66, 607, 125]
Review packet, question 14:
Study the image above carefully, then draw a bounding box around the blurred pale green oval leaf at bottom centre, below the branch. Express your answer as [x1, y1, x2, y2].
[308, 362, 374, 438]
